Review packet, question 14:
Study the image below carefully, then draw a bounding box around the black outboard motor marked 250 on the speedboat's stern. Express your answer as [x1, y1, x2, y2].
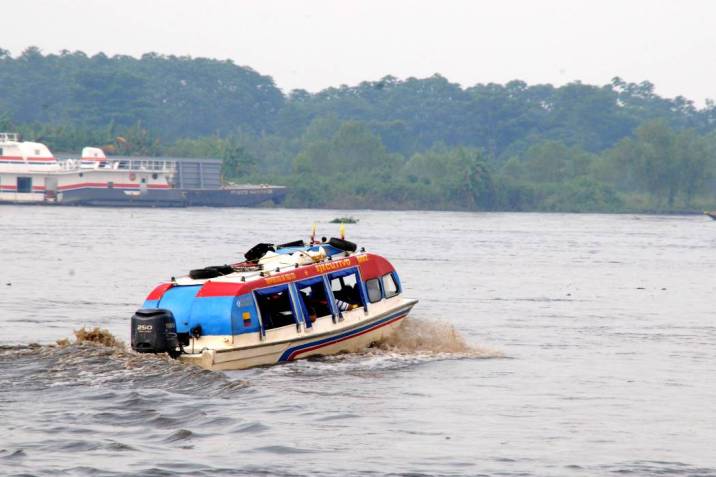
[132, 308, 181, 358]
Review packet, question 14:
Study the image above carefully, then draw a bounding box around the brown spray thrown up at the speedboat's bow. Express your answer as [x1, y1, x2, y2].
[376, 318, 504, 358]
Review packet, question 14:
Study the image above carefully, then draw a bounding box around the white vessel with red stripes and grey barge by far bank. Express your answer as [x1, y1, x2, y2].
[0, 133, 285, 207]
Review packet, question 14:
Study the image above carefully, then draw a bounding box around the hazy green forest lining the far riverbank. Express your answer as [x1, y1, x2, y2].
[0, 47, 716, 212]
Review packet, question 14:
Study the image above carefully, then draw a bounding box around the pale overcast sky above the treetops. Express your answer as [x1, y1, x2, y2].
[5, 0, 716, 104]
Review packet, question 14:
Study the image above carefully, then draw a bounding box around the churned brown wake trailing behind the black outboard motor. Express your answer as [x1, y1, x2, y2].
[0, 328, 247, 397]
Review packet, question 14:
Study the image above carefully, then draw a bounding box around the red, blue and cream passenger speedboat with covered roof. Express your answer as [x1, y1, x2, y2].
[131, 232, 417, 370]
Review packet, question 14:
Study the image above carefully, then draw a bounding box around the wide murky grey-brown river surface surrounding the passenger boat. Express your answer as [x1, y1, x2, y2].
[0, 206, 716, 476]
